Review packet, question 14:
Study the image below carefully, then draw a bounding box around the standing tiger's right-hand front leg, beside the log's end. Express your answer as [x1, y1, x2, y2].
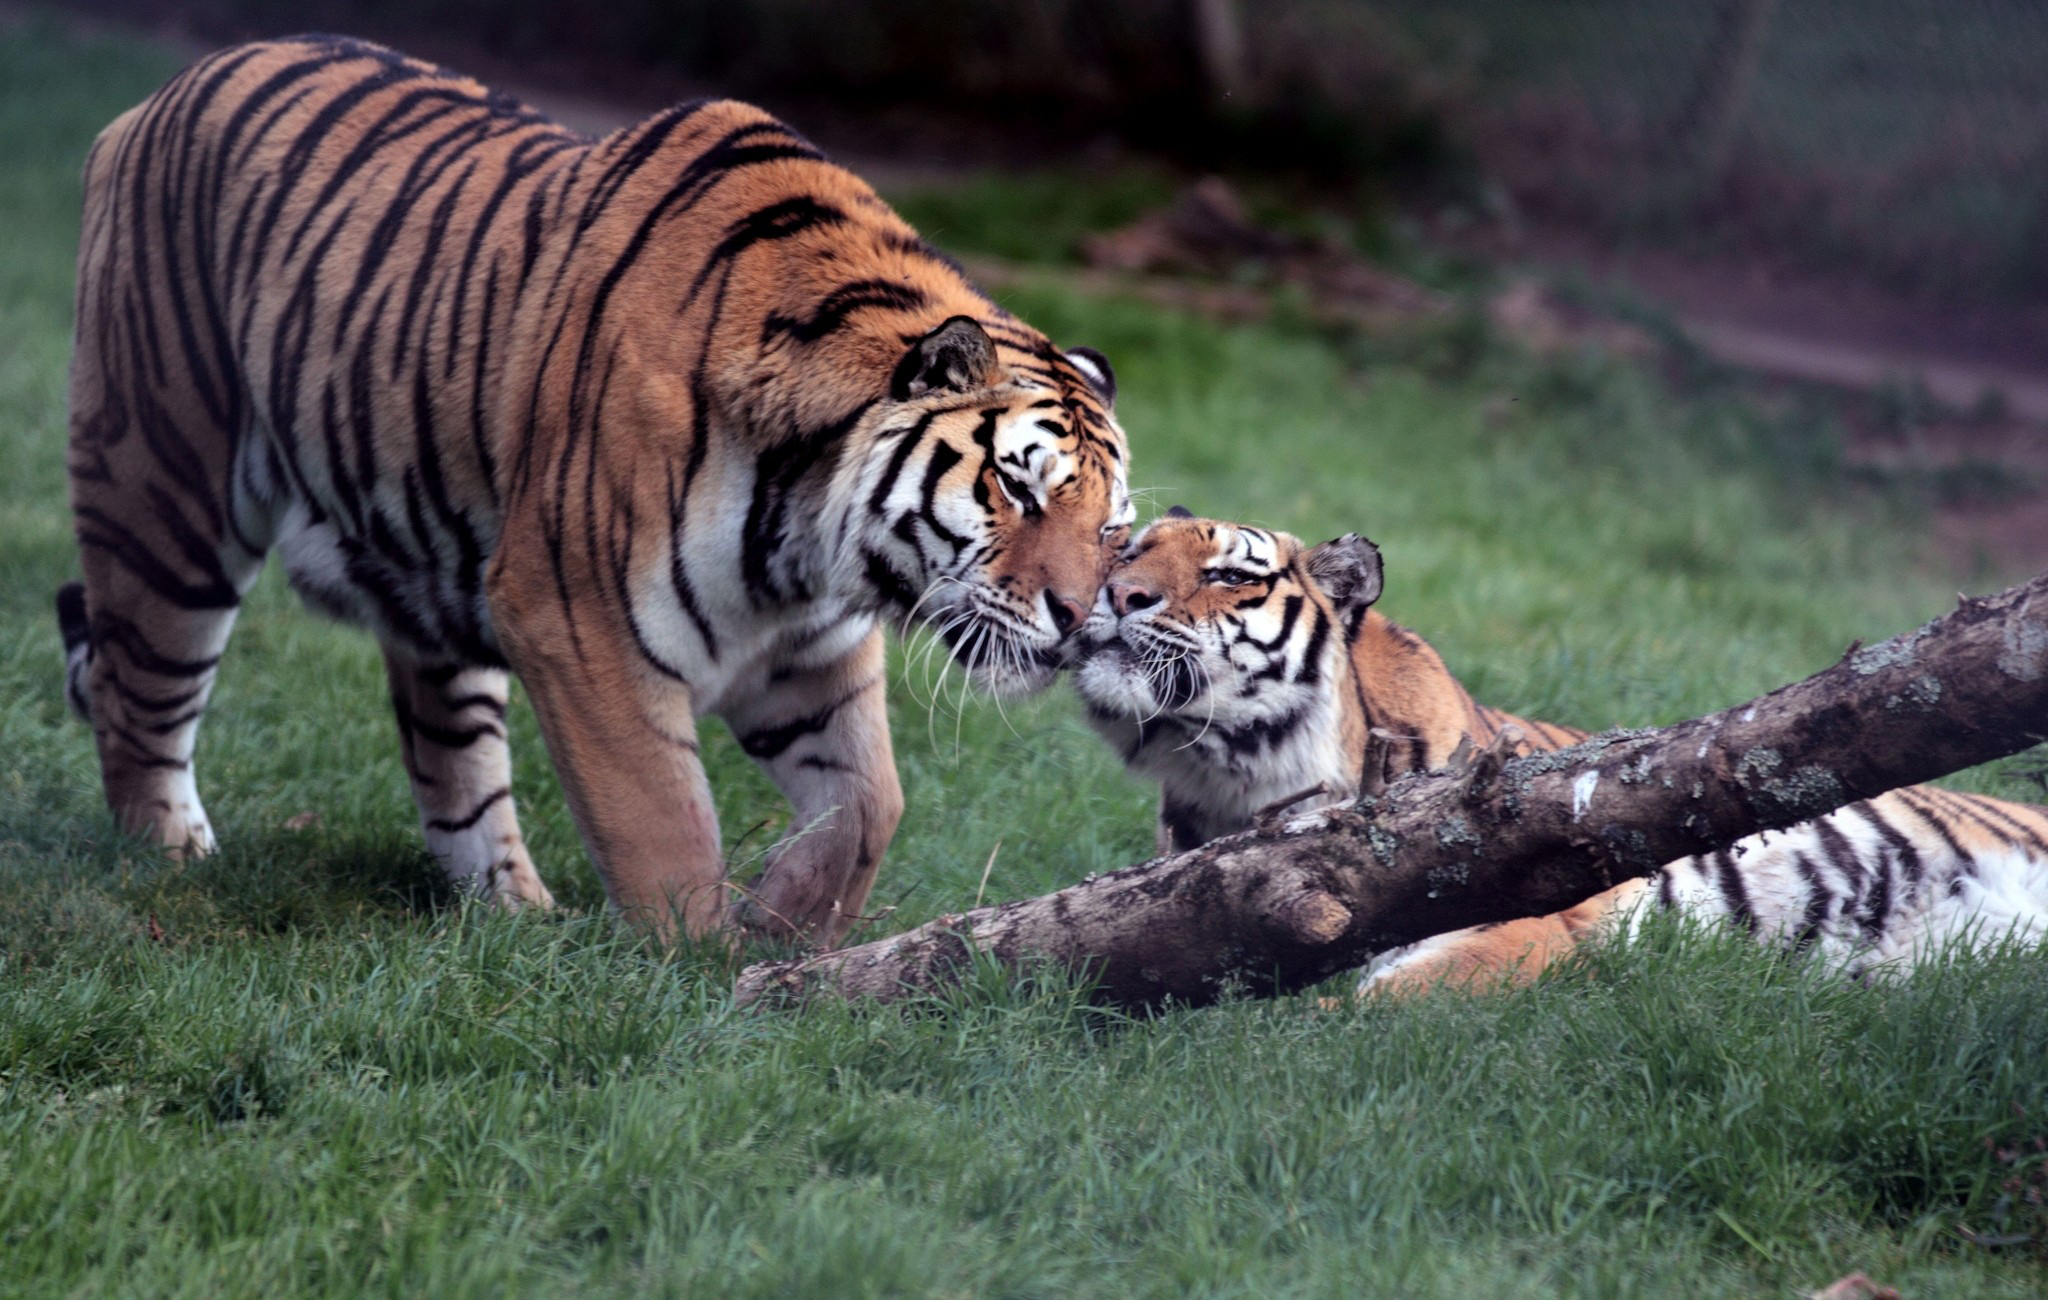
[727, 631, 903, 946]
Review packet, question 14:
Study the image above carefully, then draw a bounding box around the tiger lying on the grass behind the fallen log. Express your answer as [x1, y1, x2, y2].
[1073, 508, 2048, 993]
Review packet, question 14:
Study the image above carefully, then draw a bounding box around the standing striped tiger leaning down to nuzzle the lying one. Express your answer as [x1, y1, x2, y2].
[57, 37, 1130, 940]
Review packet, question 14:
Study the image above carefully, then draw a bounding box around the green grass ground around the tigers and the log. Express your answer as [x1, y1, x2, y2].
[0, 12, 2048, 1298]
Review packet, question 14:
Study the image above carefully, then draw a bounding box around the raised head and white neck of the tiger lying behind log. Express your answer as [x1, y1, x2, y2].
[1067, 506, 1380, 848]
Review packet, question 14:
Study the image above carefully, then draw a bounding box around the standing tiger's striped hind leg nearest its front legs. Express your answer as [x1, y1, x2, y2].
[385, 645, 555, 909]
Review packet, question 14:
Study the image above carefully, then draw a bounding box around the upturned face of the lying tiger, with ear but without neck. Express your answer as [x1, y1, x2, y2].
[1069, 506, 1380, 732]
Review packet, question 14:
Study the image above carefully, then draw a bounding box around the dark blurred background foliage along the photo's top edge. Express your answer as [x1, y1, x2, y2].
[74, 0, 2048, 299]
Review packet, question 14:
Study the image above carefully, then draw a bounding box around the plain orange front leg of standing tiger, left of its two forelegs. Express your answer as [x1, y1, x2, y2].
[489, 551, 725, 940]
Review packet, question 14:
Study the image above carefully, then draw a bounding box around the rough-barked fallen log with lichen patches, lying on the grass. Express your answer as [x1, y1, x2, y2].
[737, 573, 2048, 1009]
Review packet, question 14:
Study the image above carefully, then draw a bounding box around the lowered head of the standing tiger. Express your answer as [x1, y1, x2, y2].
[842, 315, 1133, 694]
